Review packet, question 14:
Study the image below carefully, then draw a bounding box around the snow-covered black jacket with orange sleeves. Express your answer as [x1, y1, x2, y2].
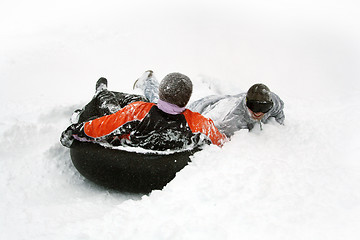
[74, 102, 226, 150]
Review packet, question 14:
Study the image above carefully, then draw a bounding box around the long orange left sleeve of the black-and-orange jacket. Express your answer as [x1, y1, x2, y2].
[84, 102, 155, 138]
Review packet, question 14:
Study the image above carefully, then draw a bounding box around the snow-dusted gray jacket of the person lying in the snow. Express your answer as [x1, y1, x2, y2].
[187, 93, 285, 137]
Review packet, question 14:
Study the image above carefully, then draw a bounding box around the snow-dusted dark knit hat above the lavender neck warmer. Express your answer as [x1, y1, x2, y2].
[159, 73, 192, 107]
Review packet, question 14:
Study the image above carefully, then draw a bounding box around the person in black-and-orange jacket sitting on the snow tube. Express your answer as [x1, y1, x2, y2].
[60, 71, 227, 151]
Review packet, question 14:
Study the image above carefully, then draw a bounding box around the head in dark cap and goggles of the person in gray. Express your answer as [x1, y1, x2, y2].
[246, 83, 273, 120]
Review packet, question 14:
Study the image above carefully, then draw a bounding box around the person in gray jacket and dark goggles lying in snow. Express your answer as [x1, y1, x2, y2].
[188, 83, 285, 137]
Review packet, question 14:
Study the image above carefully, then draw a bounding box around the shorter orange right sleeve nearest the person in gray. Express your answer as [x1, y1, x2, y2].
[183, 109, 227, 147]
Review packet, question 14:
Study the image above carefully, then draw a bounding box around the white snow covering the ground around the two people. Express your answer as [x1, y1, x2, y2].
[0, 0, 360, 240]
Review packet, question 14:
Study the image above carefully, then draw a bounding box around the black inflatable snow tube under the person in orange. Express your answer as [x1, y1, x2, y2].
[70, 141, 199, 193]
